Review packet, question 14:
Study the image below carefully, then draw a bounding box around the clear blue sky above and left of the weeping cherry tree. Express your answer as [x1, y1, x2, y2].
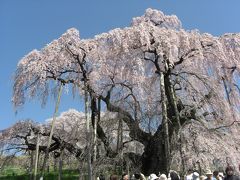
[0, 0, 240, 129]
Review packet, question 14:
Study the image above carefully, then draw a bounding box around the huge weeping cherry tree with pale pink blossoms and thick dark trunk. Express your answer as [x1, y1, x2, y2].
[13, 9, 240, 175]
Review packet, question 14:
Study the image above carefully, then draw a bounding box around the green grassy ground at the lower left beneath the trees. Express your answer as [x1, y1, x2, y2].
[0, 167, 79, 180]
